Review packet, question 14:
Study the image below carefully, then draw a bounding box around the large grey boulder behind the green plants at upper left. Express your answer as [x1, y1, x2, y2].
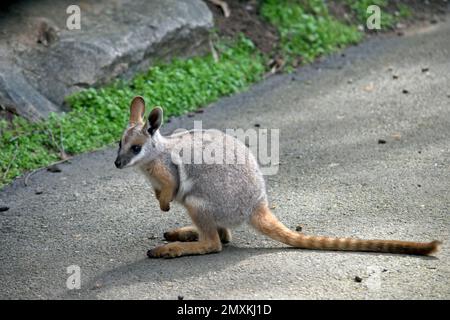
[0, 0, 213, 120]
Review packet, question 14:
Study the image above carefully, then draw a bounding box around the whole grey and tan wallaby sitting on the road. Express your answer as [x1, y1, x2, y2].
[115, 96, 441, 258]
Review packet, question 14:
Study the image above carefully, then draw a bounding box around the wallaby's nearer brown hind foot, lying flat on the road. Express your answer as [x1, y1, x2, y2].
[147, 234, 222, 258]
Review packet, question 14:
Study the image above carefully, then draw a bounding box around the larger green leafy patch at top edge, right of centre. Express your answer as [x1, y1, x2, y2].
[261, 0, 362, 66]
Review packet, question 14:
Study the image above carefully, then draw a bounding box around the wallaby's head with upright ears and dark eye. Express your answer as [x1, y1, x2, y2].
[114, 96, 163, 169]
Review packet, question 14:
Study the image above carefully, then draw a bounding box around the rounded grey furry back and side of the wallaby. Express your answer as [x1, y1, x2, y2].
[169, 130, 267, 228]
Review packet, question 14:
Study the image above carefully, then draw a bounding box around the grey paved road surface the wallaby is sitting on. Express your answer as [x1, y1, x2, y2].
[0, 19, 450, 299]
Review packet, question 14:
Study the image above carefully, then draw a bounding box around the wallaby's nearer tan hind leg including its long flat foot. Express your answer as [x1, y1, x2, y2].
[147, 205, 222, 258]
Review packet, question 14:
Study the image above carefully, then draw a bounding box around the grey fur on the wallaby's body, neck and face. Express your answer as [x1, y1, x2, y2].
[119, 112, 267, 232]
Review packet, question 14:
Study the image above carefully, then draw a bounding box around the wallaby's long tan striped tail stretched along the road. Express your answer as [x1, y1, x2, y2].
[251, 204, 441, 255]
